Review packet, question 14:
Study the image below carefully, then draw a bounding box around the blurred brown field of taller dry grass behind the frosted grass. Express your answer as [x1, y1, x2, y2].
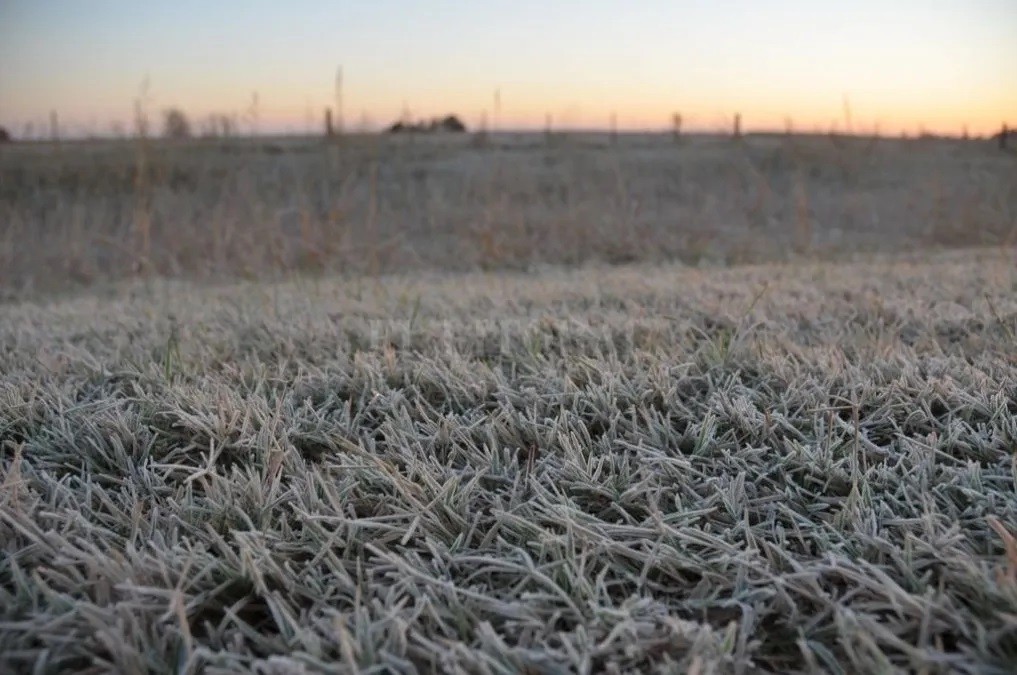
[0, 134, 1017, 296]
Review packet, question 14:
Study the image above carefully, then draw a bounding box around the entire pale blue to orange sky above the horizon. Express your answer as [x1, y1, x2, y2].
[0, 0, 1017, 136]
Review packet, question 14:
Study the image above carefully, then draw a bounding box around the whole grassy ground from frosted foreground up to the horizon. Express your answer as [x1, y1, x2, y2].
[0, 135, 1017, 675]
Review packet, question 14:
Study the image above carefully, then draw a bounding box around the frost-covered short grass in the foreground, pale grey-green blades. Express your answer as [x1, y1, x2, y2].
[0, 251, 1017, 673]
